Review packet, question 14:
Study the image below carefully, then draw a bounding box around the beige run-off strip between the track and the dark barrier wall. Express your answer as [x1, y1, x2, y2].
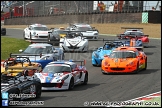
[3, 23, 161, 38]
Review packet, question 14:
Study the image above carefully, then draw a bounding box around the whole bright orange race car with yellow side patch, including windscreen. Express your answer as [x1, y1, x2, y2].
[101, 46, 147, 74]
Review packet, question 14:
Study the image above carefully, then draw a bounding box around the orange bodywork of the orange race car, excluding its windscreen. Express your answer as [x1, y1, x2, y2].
[101, 47, 147, 73]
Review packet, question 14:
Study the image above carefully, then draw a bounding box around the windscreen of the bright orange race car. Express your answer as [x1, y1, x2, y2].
[109, 51, 136, 58]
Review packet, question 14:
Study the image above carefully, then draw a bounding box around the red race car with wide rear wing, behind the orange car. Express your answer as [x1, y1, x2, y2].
[117, 27, 149, 47]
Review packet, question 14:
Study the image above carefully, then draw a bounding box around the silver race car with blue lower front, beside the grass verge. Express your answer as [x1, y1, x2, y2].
[18, 40, 65, 68]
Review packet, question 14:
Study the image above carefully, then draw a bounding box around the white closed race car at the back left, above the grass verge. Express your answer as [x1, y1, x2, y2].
[23, 24, 50, 40]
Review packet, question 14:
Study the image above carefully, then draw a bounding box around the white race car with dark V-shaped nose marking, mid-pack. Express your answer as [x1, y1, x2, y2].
[60, 31, 89, 52]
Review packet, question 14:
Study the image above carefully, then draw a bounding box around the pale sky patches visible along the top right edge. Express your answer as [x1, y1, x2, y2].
[97, 1, 161, 10]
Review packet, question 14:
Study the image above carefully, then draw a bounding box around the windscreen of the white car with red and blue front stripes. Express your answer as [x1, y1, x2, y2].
[43, 64, 71, 73]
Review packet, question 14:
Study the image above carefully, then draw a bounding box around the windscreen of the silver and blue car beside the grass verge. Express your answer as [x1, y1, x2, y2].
[23, 46, 52, 54]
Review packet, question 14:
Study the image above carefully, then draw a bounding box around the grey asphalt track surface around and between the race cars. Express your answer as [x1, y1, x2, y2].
[3, 29, 161, 107]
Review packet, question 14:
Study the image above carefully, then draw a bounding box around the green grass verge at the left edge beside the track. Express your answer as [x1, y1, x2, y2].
[1, 36, 30, 60]
